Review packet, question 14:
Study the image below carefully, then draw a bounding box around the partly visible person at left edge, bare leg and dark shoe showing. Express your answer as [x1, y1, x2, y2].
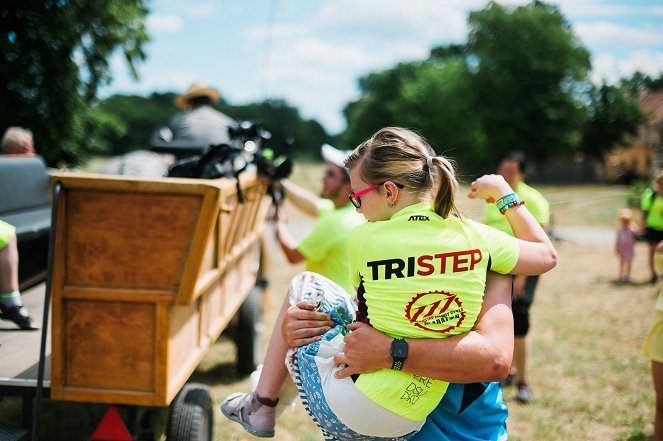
[0, 221, 34, 329]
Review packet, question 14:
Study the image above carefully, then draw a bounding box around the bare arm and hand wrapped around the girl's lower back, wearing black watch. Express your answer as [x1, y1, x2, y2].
[334, 272, 513, 383]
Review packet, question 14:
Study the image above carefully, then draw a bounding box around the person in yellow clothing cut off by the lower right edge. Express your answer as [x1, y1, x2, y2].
[644, 242, 663, 441]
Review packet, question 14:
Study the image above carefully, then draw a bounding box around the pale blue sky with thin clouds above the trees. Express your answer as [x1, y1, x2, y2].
[101, 0, 663, 133]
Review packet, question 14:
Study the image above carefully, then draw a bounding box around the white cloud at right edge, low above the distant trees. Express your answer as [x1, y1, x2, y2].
[591, 49, 663, 84]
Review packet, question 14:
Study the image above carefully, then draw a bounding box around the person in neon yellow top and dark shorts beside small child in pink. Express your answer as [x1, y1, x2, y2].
[640, 170, 663, 283]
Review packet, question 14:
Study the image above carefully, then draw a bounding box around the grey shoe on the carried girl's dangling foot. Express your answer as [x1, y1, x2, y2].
[221, 392, 276, 438]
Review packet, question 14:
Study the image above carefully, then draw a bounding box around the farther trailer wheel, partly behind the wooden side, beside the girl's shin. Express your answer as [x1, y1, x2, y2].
[235, 286, 264, 375]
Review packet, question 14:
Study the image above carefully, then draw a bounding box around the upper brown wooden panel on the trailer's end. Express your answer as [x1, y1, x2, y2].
[65, 190, 202, 292]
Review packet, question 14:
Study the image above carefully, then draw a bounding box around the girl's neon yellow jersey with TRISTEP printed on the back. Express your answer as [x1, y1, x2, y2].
[348, 202, 519, 421]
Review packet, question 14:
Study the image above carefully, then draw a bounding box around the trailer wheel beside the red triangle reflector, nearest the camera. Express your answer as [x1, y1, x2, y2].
[166, 383, 214, 441]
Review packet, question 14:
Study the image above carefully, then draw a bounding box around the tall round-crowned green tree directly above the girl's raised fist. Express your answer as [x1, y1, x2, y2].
[467, 1, 590, 161]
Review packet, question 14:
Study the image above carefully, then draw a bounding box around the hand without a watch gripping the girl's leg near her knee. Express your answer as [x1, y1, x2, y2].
[281, 302, 334, 348]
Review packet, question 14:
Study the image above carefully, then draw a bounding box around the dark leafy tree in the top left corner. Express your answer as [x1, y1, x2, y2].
[0, 0, 148, 164]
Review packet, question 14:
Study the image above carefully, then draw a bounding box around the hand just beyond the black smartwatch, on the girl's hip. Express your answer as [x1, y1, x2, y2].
[334, 322, 393, 379]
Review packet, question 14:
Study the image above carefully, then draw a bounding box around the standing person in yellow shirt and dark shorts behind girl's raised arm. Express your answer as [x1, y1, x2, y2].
[486, 152, 550, 403]
